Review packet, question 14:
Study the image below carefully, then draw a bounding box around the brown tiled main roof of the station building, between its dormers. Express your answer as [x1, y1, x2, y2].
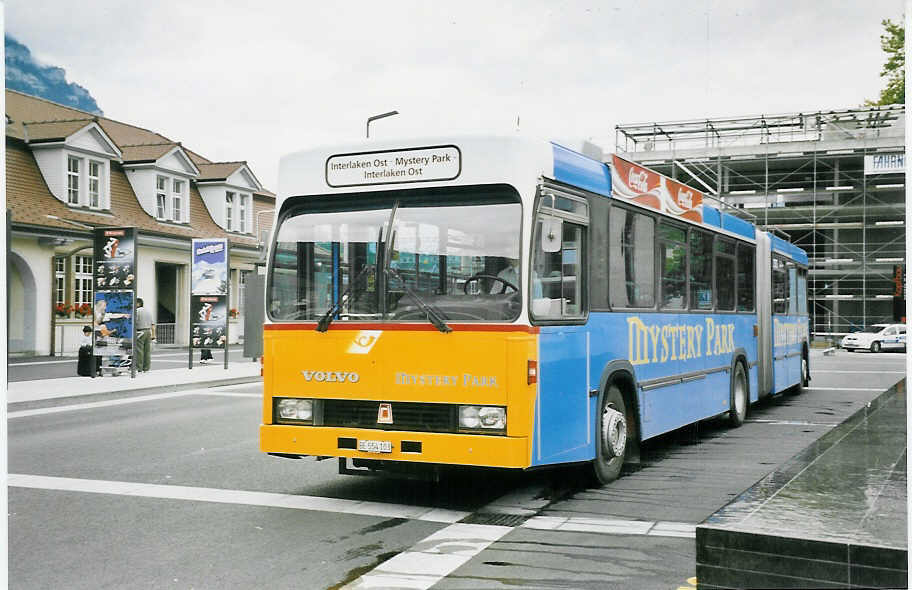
[6, 137, 273, 247]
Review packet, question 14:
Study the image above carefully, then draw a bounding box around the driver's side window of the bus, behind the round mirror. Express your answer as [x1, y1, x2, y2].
[531, 214, 586, 320]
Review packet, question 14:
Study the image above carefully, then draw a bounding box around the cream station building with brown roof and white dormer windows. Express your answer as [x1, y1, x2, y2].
[6, 90, 275, 355]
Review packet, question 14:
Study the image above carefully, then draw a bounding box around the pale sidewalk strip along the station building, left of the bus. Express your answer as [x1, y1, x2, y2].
[6, 360, 262, 403]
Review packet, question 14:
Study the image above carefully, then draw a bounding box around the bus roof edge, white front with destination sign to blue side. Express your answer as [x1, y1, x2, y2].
[276, 135, 807, 264]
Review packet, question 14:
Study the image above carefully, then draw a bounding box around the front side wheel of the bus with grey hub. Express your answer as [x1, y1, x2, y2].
[592, 384, 632, 485]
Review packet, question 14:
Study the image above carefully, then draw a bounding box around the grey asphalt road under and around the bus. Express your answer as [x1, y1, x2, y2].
[9, 352, 905, 589]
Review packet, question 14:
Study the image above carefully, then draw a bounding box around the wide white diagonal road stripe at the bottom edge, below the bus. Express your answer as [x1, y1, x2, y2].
[343, 524, 513, 590]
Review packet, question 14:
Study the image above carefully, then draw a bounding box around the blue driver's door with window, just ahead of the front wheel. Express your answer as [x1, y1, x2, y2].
[529, 194, 597, 464]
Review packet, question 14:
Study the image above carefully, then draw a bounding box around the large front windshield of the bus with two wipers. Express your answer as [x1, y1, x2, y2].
[267, 187, 522, 321]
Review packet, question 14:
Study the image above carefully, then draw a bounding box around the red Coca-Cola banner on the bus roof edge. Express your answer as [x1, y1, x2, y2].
[611, 155, 703, 223]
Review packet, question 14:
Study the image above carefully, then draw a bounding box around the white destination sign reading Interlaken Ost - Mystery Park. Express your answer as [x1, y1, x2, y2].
[326, 145, 462, 187]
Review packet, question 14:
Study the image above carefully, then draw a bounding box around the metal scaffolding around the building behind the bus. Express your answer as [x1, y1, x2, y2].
[615, 105, 905, 338]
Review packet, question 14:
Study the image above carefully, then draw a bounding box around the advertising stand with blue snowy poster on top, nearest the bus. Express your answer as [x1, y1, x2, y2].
[189, 238, 229, 368]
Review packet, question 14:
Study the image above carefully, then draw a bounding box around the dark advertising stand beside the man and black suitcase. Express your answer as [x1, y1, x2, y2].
[92, 227, 137, 375]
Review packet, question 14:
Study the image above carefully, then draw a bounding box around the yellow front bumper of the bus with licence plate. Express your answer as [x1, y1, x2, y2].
[260, 424, 530, 469]
